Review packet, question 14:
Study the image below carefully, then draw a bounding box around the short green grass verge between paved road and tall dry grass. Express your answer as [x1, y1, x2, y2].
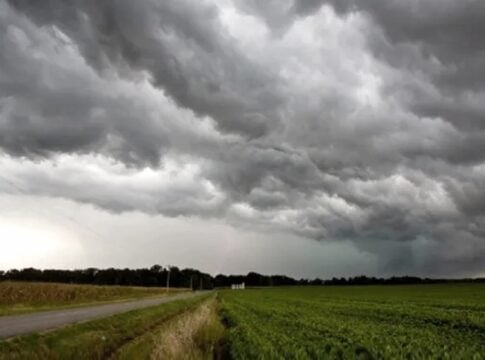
[0, 294, 212, 360]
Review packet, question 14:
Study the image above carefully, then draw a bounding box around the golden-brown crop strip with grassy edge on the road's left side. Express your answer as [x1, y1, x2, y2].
[0, 281, 187, 316]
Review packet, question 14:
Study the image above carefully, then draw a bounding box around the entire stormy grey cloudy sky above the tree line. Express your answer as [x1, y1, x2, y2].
[0, 0, 485, 278]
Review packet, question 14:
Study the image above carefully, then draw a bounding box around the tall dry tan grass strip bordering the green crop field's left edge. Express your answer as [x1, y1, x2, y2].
[113, 296, 225, 360]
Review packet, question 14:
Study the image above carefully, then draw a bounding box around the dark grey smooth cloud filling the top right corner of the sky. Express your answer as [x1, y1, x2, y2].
[325, 0, 485, 63]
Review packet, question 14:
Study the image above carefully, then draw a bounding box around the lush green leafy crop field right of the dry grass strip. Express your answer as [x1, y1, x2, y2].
[220, 284, 485, 359]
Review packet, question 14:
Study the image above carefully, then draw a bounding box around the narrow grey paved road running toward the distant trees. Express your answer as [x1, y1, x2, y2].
[0, 291, 206, 339]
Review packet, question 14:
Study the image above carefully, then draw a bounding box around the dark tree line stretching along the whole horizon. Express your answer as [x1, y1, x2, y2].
[0, 265, 485, 290]
